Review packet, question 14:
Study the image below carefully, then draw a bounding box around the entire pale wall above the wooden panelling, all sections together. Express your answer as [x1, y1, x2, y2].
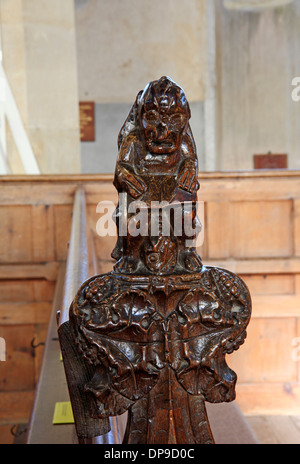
[0, 0, 300, 173]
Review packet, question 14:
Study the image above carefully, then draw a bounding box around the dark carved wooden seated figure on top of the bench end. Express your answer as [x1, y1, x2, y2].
[112, 76, 201, 273]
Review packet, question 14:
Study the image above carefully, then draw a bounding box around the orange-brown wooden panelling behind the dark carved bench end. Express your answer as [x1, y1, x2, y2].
[0, 170, 300, 436]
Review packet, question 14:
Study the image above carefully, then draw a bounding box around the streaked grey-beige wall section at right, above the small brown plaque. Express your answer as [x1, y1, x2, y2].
[215, 0, 300, 170]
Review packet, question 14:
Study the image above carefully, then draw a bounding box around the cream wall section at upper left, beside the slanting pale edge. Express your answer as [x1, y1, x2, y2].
[0, 0, 81, 174]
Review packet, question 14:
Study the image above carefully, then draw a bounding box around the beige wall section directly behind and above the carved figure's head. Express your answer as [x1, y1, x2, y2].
[75, 0, 206, 103]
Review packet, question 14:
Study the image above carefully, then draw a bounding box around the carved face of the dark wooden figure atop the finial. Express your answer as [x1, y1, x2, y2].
[141, 78, 190, 155]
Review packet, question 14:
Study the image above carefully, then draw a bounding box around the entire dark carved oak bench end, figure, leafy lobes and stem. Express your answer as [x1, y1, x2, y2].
[69, 77, 251, 444]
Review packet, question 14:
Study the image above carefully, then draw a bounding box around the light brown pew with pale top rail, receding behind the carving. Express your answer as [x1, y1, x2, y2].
[27, 187, 258, 444]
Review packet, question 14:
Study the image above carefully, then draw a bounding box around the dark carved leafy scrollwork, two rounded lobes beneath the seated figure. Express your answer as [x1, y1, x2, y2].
[71, 268, 251, 424]
